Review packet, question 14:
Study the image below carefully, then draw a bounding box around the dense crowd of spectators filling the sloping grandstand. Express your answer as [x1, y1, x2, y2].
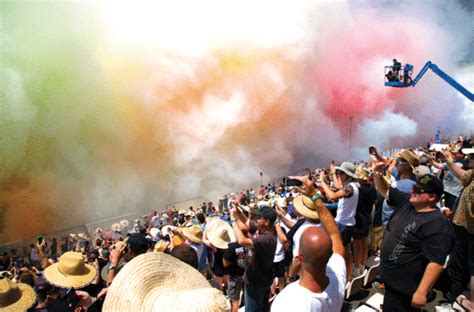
[0, 137, 474, 311]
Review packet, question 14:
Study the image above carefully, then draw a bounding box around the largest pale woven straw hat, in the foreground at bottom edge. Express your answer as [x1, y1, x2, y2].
[103, 252, 230, 312]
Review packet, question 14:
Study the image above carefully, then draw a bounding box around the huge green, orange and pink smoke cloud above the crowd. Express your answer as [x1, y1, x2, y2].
[0, 1, 474, 241]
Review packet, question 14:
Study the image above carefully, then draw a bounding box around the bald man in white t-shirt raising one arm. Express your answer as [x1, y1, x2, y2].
[272, 177, 346, 312]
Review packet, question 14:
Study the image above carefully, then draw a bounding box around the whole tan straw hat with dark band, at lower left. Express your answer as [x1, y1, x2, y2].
[44, 251, 97, 288]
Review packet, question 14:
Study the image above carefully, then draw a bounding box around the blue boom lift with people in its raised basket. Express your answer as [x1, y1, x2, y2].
[385, 61, 474, 102]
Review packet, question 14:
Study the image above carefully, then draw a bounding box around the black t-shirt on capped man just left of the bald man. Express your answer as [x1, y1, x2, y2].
[244, 232, 276, 286]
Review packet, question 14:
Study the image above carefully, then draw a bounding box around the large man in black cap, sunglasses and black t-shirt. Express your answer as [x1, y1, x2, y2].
[374, 162, 455, 311]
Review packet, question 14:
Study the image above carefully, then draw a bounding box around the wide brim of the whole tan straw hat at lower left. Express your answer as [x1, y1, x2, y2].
[43, 262, 97, 288]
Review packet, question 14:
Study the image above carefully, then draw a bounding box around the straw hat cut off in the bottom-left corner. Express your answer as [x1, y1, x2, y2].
[0, 278, 36, 311]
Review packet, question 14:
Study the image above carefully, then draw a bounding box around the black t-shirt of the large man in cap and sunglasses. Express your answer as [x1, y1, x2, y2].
[380, 188, 455, 295]
